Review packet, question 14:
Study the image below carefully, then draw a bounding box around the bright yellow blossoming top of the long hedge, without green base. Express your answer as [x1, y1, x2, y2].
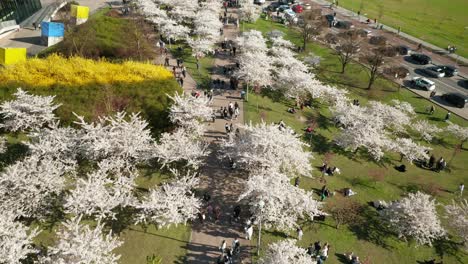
[0, 54, 172, 86]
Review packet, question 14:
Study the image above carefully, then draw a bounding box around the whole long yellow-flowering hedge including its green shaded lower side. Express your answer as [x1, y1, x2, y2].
[0, 55, 181, 131]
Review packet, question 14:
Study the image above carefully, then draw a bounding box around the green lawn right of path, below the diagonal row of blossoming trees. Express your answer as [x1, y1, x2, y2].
[245, 91, 468, 263]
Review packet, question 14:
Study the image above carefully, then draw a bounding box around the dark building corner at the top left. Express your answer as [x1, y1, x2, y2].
[0, 0, 41, 24]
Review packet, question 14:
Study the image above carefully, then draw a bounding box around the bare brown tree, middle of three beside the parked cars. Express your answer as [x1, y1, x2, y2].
[335, 30, 361, 73]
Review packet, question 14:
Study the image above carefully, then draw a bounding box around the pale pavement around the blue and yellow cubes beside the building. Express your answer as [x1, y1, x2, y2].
[0, 0, 107, 56]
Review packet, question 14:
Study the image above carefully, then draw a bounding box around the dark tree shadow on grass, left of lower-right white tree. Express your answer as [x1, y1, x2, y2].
[349, 207, 393, 249]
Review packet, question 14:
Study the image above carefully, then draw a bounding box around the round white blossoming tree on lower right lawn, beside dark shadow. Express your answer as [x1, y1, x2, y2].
[382, 192, 445, 246]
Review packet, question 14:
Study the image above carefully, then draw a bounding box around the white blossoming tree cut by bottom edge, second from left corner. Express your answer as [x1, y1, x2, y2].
[40, 216, 123, 264]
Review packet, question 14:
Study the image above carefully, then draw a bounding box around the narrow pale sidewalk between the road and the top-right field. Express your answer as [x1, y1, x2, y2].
[310, 0, 468, 65]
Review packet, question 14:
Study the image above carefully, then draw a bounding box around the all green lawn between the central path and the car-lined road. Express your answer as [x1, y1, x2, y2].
[244, 19, 468, 263]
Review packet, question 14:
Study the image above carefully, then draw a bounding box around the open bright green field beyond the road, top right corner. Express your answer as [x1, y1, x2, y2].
[328, 0, 468, 58]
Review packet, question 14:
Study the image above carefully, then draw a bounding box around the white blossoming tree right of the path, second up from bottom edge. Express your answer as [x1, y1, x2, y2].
[239, 170, 324, 230]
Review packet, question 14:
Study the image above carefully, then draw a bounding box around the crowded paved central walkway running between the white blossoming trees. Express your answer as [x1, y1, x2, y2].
[186, 9, 251, 264]
